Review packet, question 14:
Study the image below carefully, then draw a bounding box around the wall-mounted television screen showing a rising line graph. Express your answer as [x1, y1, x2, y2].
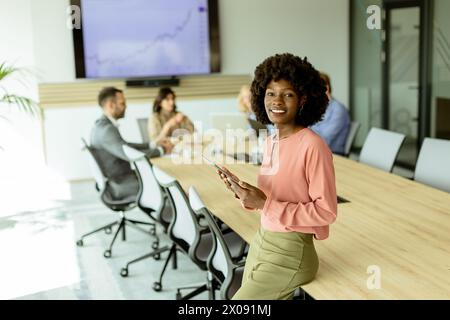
[71, 0, 220, 79]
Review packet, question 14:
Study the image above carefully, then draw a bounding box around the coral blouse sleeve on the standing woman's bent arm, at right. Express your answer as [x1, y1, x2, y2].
[263, 142, 337, 227]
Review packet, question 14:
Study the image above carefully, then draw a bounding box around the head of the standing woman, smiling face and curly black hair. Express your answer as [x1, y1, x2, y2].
[251, 53, 328, 134]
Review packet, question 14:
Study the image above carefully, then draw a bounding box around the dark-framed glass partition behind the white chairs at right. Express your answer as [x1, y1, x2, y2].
[350, 0, 450, 170]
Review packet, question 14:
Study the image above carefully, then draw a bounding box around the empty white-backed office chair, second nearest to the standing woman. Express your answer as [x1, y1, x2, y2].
[153, 166, 245, 300]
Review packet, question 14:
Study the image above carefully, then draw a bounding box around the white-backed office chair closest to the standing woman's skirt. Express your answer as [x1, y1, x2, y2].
[189, 187, 245, 300]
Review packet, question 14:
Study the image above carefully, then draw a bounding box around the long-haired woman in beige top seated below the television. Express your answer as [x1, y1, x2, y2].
[148, 88, 194, 142]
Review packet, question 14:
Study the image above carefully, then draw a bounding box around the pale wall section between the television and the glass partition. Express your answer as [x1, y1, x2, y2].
[219, 0, 350, 105]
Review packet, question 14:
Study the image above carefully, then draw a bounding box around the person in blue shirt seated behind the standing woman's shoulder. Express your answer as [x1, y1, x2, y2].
[311, 73, 350, 154]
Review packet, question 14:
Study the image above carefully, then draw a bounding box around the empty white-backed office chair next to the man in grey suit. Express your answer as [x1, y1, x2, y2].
[120, 146, 176, 282]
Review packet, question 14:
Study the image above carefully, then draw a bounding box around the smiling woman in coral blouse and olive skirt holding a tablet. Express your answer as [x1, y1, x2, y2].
[216, 54, 337, 299]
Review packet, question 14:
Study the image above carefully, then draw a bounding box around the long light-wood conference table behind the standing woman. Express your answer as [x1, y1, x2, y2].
[152, 156, 450, 299]
